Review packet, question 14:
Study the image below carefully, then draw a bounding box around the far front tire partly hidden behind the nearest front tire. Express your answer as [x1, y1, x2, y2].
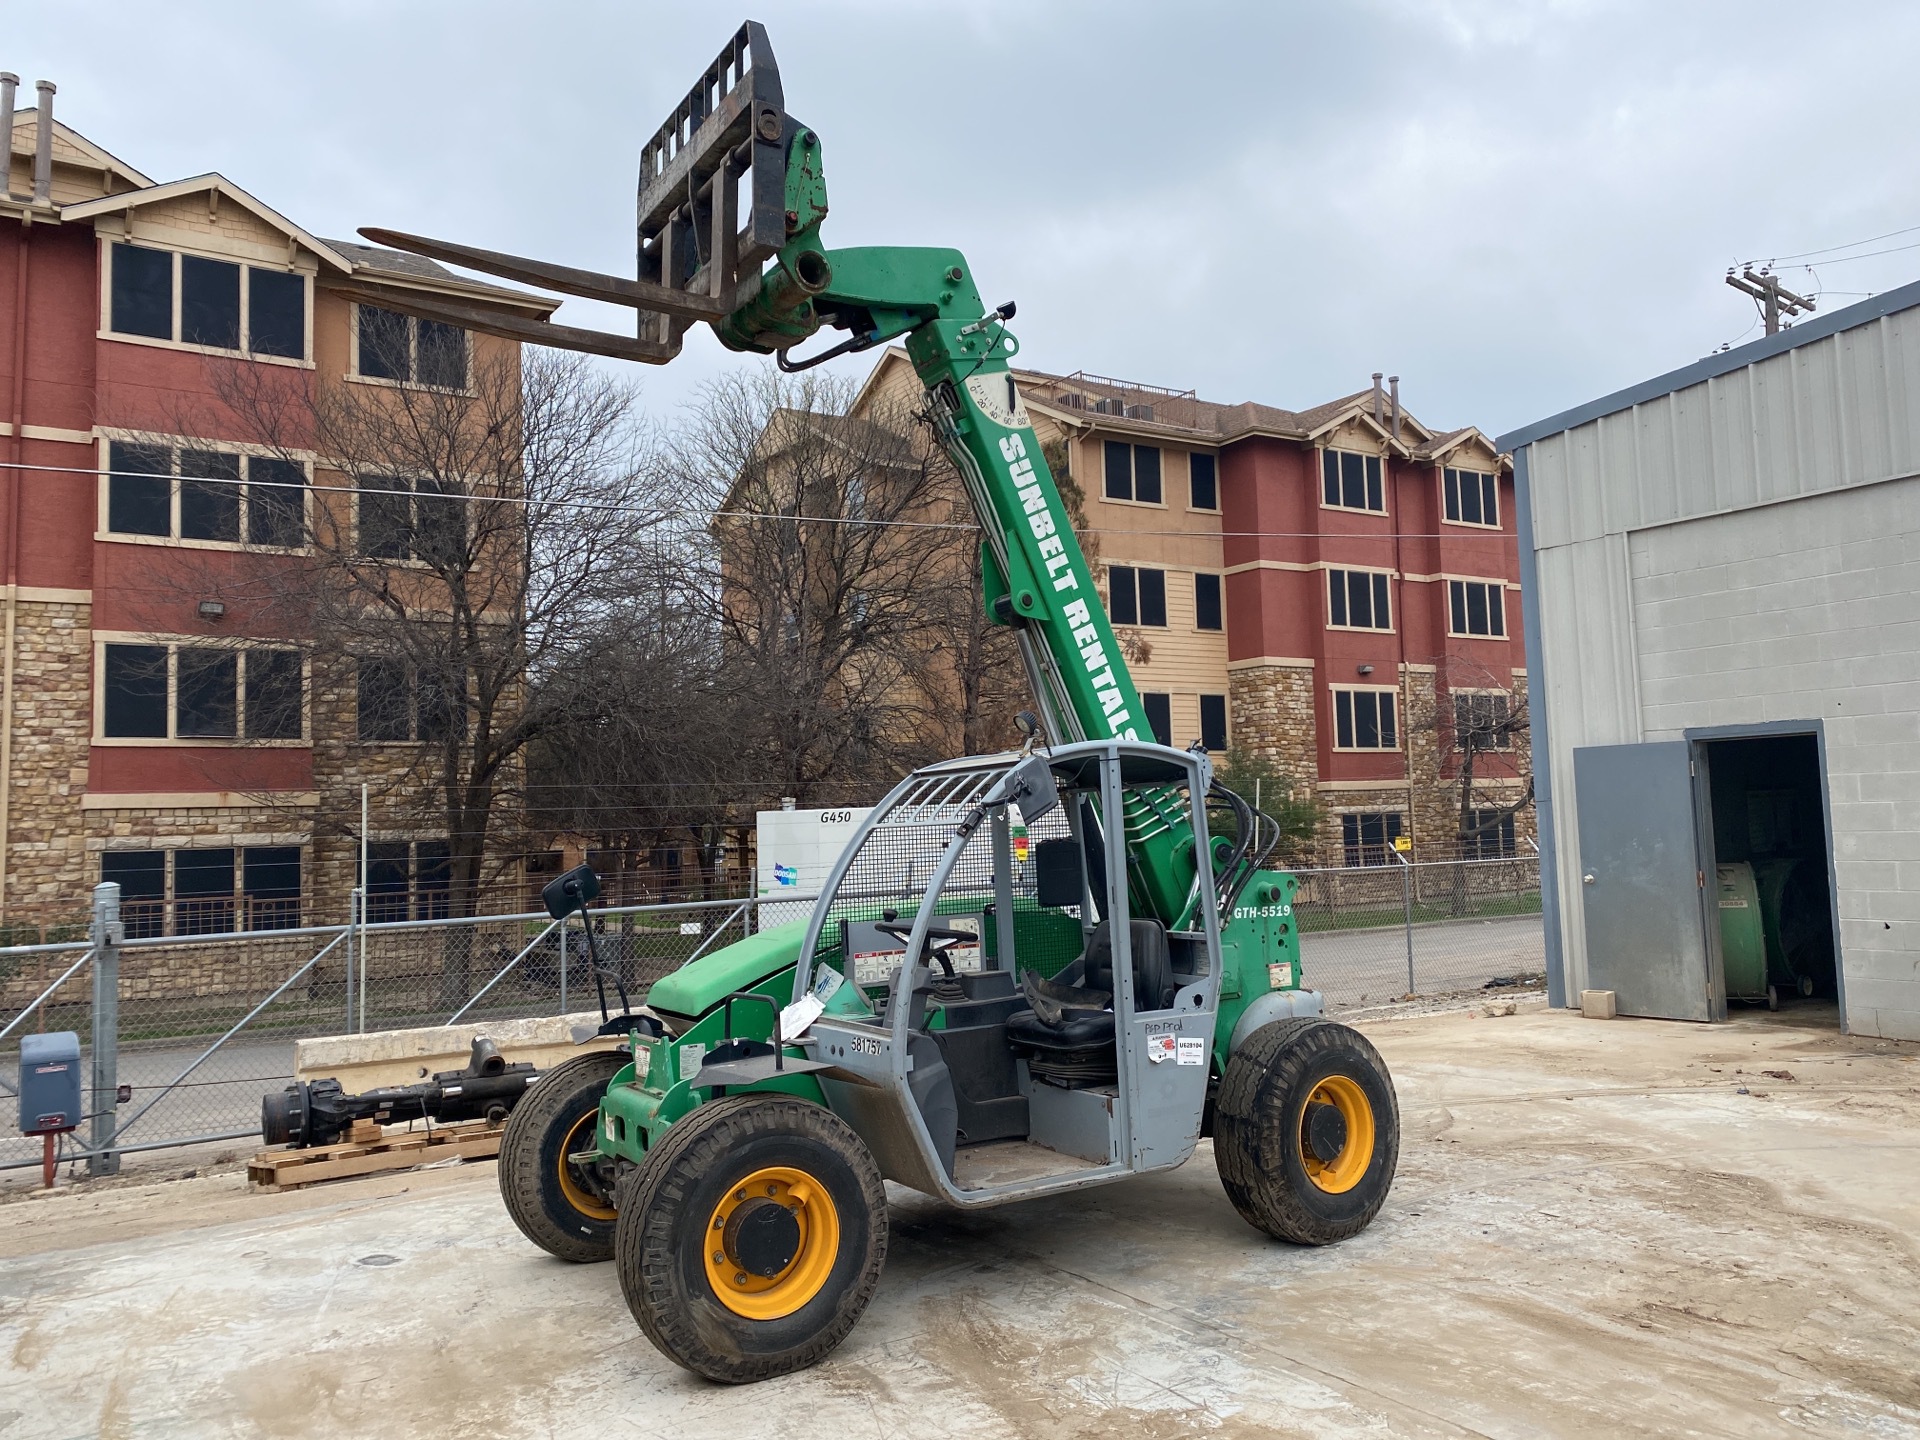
[499, 1050, 632, 1265]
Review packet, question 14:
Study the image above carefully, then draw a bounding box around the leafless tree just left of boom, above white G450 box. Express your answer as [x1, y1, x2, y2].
[676, 371, 968, 804]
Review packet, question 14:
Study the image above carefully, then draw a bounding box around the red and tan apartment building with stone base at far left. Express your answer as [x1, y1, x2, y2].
[0, 77, 553, 939]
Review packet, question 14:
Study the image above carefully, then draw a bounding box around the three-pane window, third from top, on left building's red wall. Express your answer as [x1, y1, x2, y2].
[100, 645, 305, 739]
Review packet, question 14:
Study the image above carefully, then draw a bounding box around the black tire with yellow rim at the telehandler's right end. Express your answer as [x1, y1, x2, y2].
[1213, 1020, 1400, 1244]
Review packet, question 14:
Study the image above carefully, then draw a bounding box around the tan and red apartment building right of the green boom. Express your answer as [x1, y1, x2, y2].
[860, 349, 1532, 864]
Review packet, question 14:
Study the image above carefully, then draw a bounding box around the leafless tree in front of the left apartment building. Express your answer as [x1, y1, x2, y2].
[182, 337, 657, 993]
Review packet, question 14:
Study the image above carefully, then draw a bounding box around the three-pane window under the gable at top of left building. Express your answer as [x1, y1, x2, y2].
[108, 242, 307, 359]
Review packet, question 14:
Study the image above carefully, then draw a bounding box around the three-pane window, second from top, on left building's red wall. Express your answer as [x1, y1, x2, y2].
[106, 440, 307, 549]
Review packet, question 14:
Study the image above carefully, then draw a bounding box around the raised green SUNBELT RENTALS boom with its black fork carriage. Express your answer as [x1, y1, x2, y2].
[361, 23, 1202, 927]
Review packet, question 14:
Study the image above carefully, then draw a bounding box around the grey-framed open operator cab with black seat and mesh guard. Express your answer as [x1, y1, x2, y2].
[795, 741, 1219, 1204]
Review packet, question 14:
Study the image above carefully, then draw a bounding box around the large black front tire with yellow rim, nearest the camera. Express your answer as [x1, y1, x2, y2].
[614, 1094, 887, 1384]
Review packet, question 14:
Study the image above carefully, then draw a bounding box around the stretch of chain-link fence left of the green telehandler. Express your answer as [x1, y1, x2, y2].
[0, 885, 810, 1173]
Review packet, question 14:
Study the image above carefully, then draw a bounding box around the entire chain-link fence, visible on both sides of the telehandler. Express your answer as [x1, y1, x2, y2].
[0, 854, 1546, 1171]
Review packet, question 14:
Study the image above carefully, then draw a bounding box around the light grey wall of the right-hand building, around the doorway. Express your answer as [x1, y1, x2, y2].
[1526, 309, 1920, 1039]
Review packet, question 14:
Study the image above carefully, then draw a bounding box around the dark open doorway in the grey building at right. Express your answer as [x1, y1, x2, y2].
[1712, 733, 1841, 1021]
